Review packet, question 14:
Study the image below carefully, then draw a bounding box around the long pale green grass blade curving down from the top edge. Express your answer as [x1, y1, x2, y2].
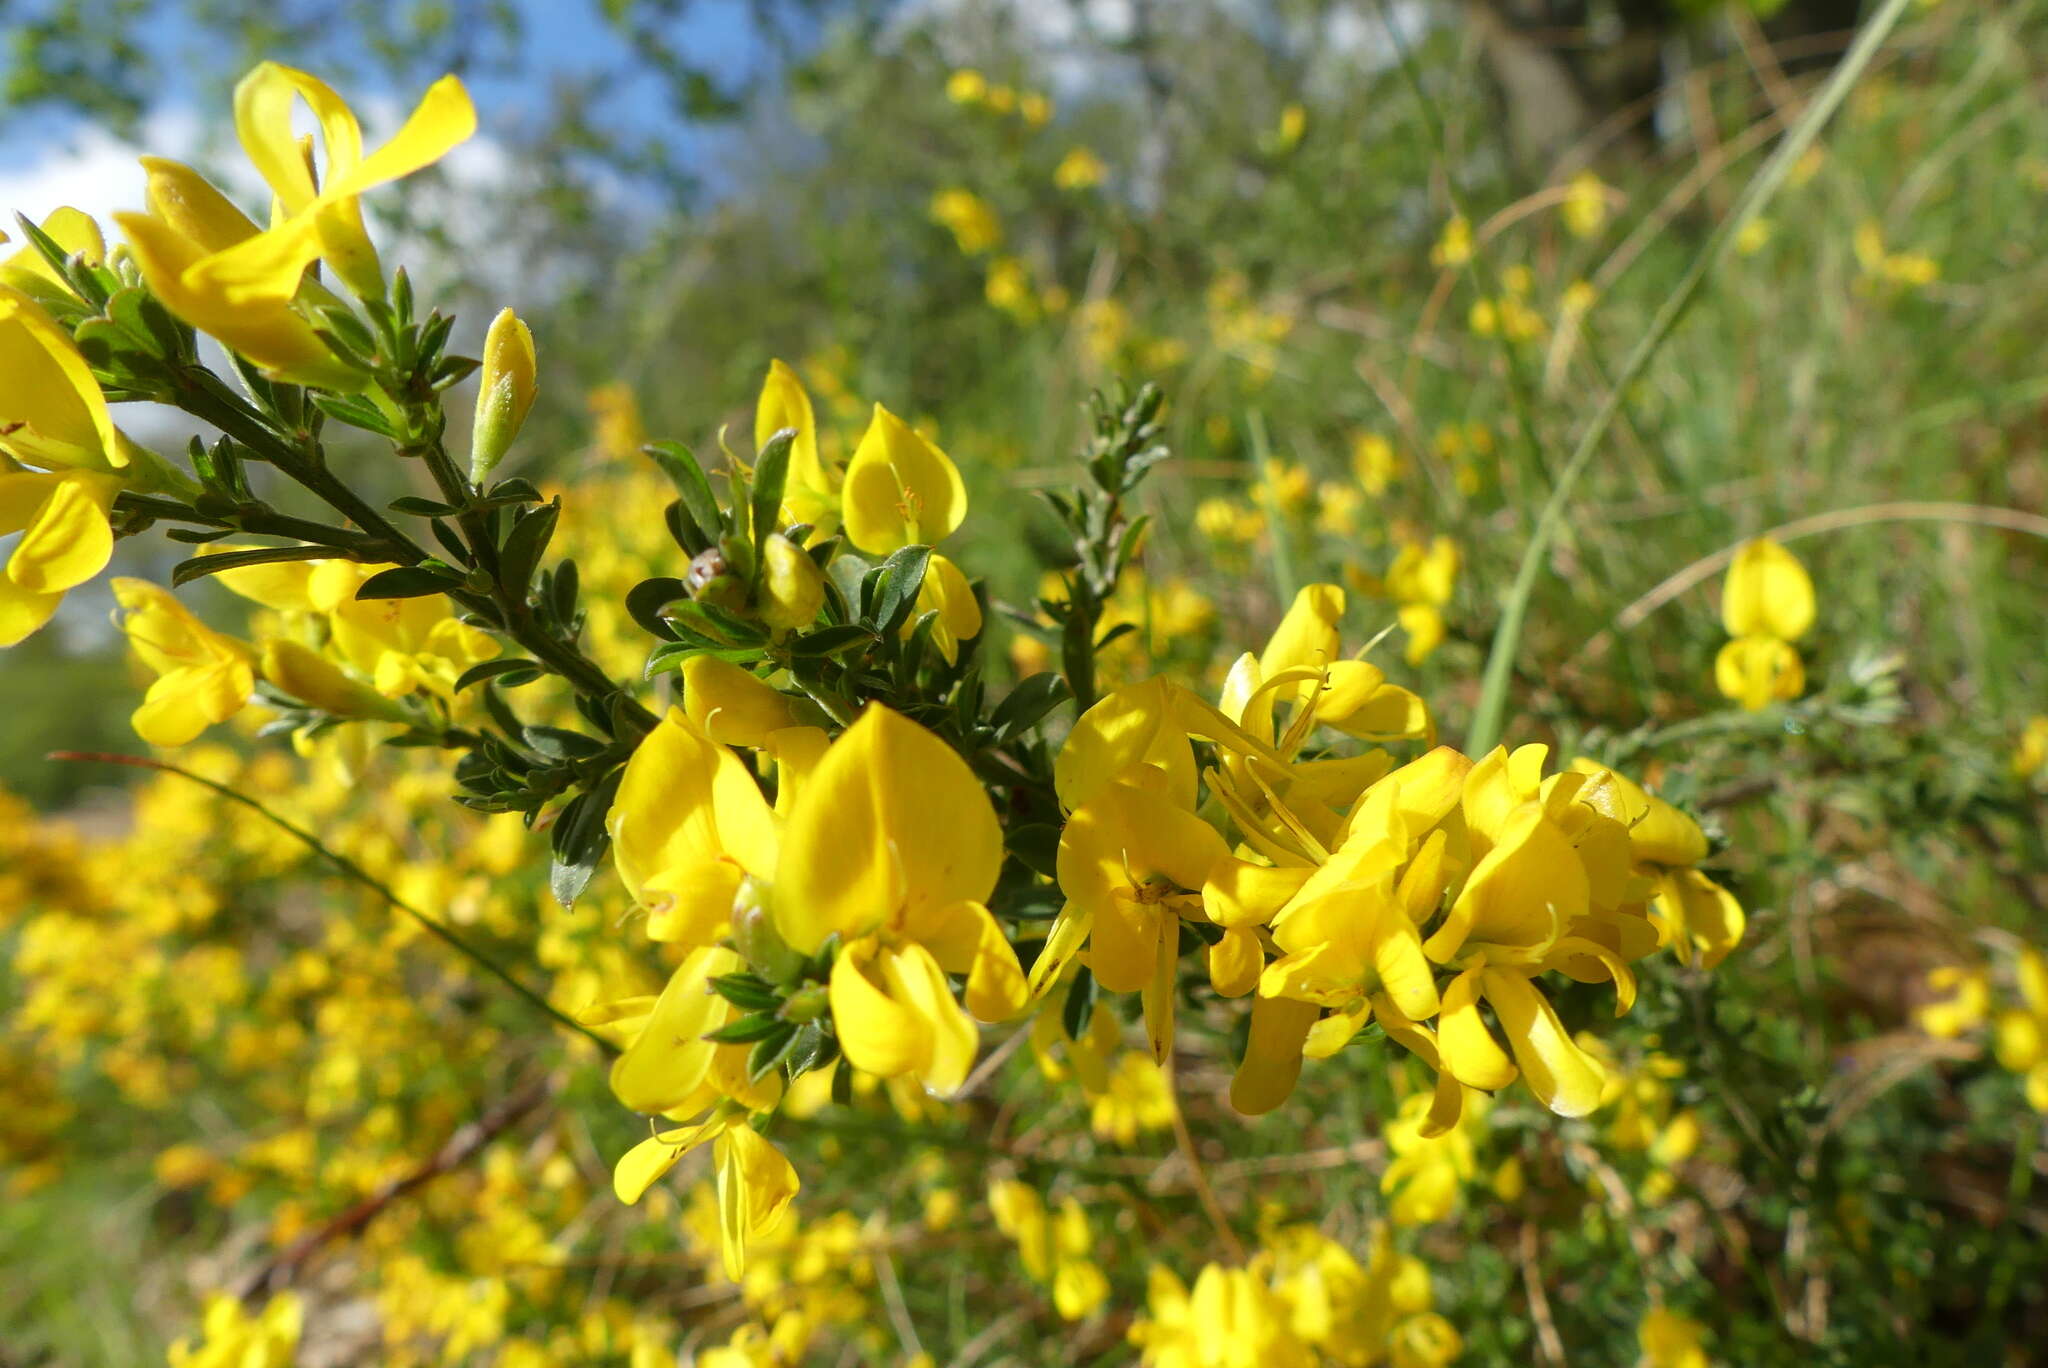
[1466, 0, 1913, 754]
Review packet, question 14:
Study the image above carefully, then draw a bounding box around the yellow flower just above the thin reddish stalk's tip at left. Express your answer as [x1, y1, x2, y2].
[113, 578, 256, 745]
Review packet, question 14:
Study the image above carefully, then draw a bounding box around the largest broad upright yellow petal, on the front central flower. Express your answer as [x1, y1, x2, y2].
[774, 704, 1004, 954]
